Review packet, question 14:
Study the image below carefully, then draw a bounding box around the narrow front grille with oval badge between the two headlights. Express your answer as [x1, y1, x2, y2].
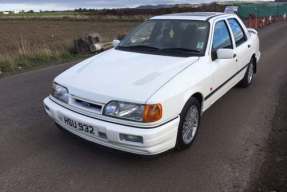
[71, 96, 103, 114]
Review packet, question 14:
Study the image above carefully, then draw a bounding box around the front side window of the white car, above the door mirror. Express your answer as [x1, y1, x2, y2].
[212, 21, 233, 51]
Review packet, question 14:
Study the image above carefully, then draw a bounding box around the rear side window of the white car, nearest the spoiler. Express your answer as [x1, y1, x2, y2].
[228, 19, 246, 46]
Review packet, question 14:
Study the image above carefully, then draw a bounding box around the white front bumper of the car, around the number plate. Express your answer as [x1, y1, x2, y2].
[44, 97, 179, 155]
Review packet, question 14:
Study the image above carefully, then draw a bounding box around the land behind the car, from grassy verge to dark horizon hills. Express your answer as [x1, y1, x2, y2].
[0, 4, 224, 75]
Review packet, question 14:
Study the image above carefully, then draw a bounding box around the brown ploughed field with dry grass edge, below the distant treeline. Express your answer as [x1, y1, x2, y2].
[0, 19, 141, 73]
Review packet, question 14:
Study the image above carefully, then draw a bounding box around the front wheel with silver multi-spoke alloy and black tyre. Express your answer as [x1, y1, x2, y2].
[176, 97, 201, 150]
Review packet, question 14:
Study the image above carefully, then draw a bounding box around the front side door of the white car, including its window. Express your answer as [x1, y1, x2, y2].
[207, 20, 237, 103]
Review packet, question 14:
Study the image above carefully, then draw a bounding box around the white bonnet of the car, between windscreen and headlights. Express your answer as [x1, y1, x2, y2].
[55, 49, 198, 103]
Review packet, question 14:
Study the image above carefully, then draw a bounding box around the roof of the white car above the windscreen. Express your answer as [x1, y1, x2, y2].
[151, 12, 228, 21]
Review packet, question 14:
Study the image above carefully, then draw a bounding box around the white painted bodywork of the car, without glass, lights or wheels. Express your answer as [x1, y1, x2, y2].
[44, 14, 260, 154]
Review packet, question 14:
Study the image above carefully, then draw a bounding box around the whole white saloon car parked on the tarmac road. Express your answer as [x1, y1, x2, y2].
[44, 12, 260, 155]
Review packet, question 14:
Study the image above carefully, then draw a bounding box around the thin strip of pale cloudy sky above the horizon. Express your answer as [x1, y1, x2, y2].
[0, 0, 274, 11]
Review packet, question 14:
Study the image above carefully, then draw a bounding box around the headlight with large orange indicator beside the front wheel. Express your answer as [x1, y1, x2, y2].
[103, 101, 162, 123]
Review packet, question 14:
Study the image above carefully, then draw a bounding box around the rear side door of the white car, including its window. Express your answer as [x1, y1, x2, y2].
[227, 18, 252, 71]
